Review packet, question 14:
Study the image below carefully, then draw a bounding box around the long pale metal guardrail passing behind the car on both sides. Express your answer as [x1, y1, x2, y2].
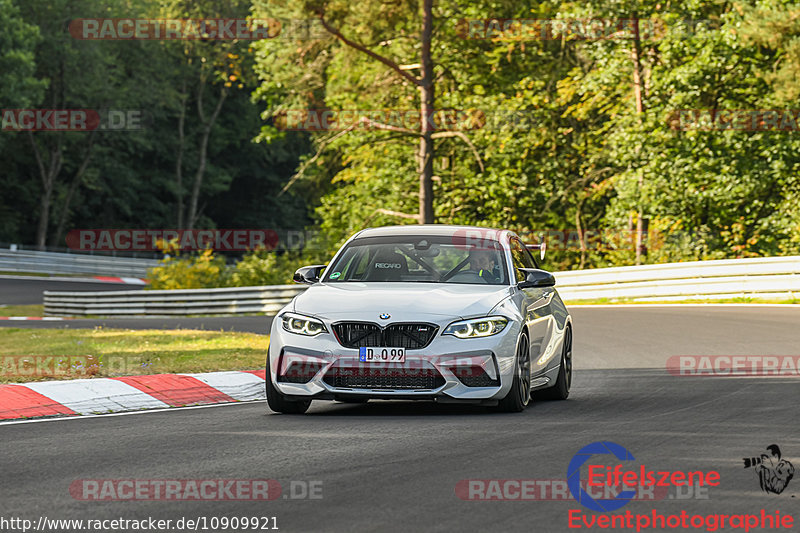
[44, 256, 800, 317]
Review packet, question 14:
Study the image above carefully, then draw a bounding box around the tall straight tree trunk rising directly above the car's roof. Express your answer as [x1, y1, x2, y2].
[417, 0, 435, 224]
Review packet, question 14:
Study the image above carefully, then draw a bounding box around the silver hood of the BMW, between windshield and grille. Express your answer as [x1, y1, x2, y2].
[294, 282, 511, 322]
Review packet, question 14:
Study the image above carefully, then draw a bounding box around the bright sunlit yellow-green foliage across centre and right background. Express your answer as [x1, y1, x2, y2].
[255, 0, 800, 269]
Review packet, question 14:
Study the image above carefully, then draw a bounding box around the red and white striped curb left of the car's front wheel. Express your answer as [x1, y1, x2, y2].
[0, 370, 265, 420]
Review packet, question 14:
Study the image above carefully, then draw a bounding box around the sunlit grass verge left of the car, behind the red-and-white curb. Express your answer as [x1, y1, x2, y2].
[0, 327, 269, 383]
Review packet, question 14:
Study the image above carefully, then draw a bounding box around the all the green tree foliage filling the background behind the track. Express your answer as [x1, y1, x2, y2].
[0, 0, 800, 276]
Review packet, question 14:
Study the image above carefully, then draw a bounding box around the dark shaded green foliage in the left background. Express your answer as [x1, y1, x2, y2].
[0, 0, 312, 247]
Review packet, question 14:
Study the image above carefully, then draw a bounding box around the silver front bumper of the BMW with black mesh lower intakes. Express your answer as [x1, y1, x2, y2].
[269, 320, 520, 401]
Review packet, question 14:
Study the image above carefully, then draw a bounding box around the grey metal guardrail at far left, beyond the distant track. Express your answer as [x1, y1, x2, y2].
[0, 249, 158, 278]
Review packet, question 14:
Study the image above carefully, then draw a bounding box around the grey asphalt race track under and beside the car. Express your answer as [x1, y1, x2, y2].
[0, 306, 800, 532]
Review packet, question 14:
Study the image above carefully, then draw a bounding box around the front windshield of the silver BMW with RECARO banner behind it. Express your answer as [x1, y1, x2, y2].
[323, 235, 508, 285]
